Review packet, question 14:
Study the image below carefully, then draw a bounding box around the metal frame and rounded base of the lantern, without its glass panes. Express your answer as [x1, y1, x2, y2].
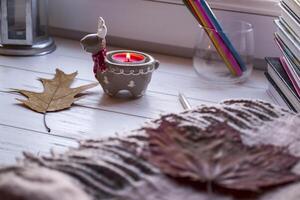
[0, 0, 56, 56]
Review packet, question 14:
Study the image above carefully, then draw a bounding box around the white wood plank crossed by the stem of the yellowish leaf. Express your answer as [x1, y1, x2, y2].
[0, 93, 146, 139]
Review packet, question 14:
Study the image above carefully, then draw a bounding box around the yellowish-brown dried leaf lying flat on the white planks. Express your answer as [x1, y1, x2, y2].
[14, 69, 98, 132]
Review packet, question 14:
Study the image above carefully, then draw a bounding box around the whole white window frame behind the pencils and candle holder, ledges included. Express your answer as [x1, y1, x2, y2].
[49, 0, 280, 67]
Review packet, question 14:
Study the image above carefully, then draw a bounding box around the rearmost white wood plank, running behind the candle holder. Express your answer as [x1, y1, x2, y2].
[0, 39, 267, 89]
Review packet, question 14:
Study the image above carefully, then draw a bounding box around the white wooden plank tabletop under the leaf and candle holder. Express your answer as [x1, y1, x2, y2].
[0, 38, 272, 164]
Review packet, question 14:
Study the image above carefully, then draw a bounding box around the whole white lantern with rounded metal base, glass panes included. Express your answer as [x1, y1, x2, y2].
[0, 0, 55, 55]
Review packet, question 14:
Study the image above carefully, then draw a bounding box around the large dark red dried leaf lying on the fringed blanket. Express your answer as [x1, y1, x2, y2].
[143, 119, 299, 191]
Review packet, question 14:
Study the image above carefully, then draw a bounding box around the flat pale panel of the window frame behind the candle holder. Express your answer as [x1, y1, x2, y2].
[49, 0, 279, 58]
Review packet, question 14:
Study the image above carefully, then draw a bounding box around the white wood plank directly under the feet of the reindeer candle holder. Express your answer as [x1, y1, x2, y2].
[0, 66, 192, 118]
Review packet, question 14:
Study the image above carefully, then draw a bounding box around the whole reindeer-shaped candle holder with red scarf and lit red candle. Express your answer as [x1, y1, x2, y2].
[80, 17, 159, 98]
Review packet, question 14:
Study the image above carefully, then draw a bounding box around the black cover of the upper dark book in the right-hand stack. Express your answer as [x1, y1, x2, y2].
[266, 57, 300, 102]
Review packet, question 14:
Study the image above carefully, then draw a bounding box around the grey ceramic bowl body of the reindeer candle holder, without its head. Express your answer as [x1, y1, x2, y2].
[96, 50, 159, 98]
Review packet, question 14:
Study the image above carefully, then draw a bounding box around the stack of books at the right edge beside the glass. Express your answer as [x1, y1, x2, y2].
[265, 0, 300, 112]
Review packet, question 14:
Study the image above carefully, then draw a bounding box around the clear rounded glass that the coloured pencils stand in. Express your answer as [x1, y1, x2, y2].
[193, 20, 254, 84]
